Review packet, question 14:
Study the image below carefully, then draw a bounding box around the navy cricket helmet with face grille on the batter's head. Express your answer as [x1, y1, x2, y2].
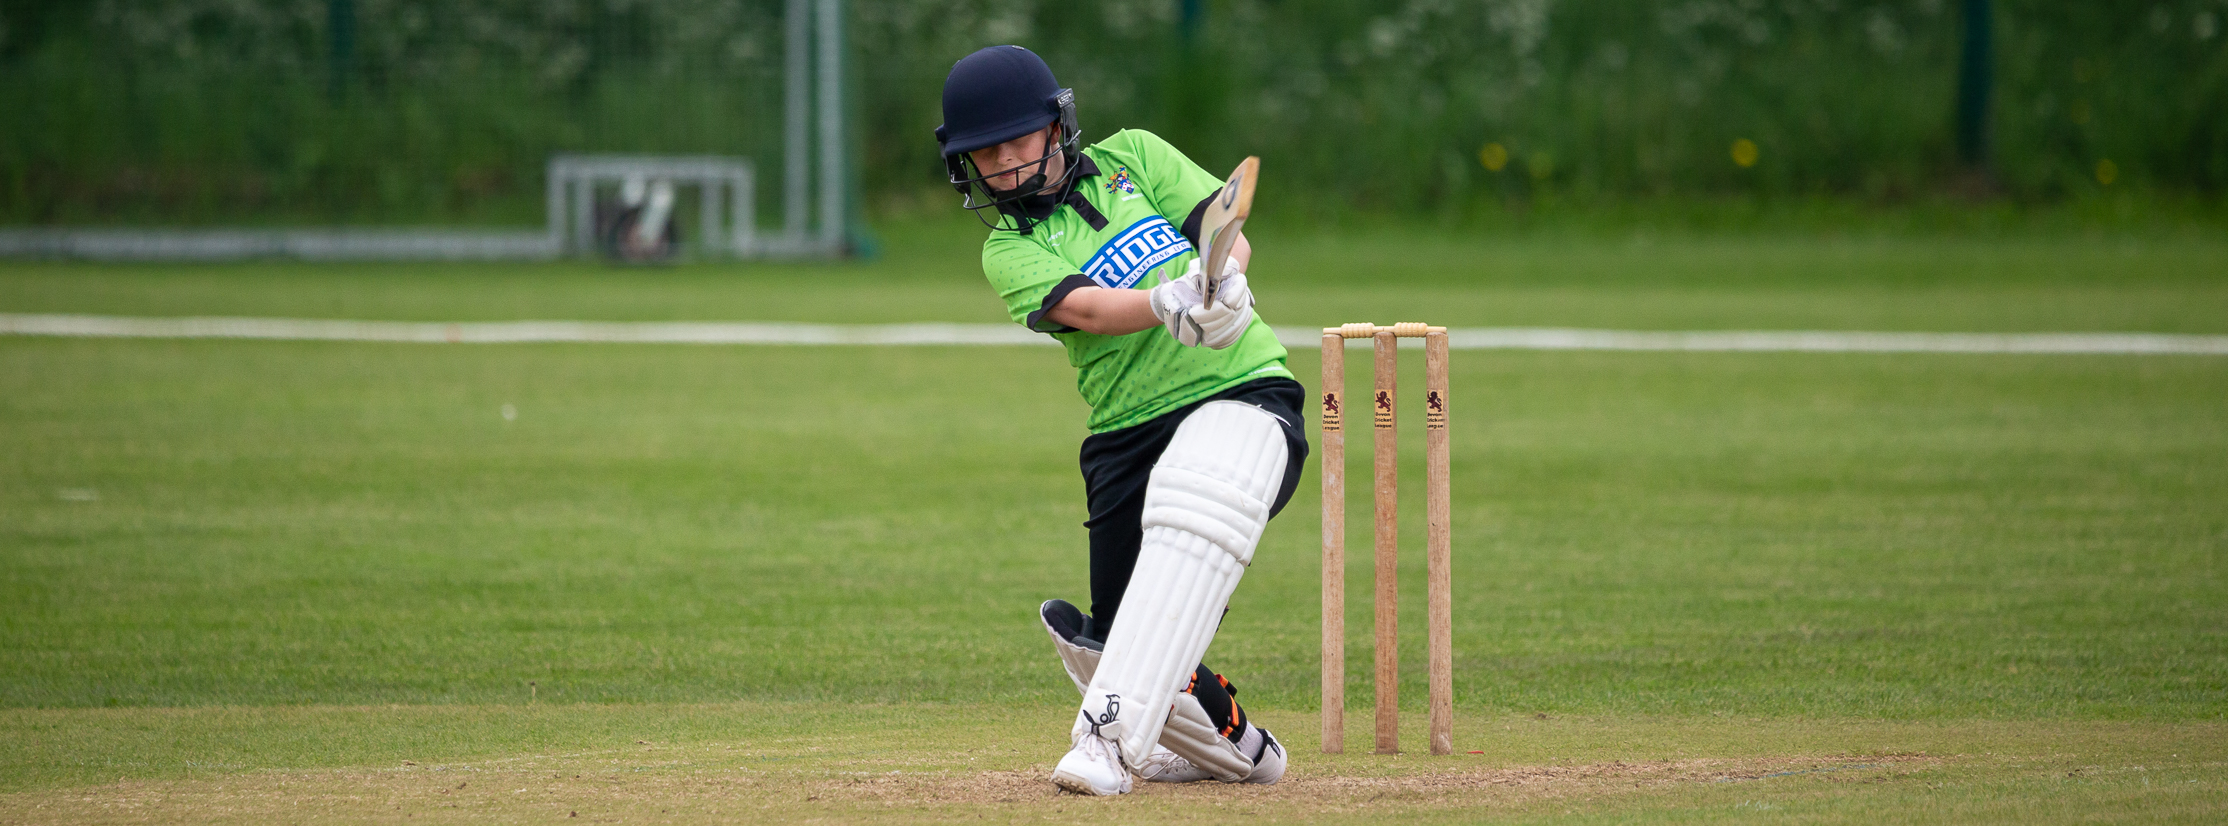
[936, 47, 1081, 229]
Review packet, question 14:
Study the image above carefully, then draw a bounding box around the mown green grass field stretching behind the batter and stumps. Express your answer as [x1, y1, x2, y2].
[0, 227, 2228, 822]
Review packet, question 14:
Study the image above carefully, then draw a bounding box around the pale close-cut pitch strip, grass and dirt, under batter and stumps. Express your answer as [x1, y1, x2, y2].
[0, 704, 2228, 824]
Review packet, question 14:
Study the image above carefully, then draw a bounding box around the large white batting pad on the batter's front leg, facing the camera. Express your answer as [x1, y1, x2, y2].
[1078, 401, 1288, 768]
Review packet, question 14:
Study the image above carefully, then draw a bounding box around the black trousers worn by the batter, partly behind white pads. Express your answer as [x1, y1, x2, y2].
[1083, 378, 1308, 737]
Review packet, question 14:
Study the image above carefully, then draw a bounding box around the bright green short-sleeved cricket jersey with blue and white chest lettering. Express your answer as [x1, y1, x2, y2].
[983, 129, 1292, 434]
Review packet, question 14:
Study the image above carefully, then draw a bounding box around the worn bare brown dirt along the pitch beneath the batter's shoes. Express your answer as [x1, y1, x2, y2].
[0, 755, 1943, 824]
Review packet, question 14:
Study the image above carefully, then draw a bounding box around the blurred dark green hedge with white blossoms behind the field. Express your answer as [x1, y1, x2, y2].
[0, 0, 2228, 223]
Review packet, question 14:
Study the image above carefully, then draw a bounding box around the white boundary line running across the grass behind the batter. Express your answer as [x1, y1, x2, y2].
[0, 314, 2228, 356]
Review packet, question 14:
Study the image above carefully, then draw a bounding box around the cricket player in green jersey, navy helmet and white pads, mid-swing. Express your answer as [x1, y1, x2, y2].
[936, 47, 1308, 795]
